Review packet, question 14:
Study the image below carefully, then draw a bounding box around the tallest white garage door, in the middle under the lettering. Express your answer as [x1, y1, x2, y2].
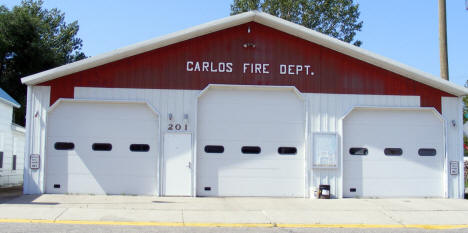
[197, 88, 305, 196]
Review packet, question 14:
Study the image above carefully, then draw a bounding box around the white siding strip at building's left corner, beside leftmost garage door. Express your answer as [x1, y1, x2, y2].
[23, 86, 50, 194]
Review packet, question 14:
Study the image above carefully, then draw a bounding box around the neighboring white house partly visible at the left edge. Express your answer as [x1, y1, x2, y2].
[0, 88, 25, 187]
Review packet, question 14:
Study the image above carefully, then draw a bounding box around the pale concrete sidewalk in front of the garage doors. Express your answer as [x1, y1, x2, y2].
[0, 194, 468, 228]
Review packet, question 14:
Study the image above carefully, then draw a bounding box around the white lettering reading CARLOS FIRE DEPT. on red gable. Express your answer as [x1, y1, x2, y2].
[185, 61, 315, 76]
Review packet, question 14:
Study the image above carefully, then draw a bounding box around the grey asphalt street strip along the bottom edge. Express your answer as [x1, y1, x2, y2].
[0, 223, 468, 233]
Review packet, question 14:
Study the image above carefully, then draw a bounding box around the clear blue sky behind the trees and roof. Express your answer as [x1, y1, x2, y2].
[1, 0, 468, 85]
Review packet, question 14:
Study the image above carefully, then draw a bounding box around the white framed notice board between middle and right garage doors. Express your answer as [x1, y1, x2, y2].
[312, 133, 338, 168]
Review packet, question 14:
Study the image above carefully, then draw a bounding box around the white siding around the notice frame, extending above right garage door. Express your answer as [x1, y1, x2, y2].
[304, 93, 420, 197]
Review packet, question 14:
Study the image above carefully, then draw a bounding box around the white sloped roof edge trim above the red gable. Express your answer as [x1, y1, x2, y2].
[21, 11, 468, 96]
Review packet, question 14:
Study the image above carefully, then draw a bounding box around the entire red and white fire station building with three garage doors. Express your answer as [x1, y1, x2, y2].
[22, 11, 468, 198]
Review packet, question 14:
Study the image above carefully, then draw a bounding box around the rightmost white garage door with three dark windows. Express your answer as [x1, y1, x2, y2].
[343, 109, 445, 197]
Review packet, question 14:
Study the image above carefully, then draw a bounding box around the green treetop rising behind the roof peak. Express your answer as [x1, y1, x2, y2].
[231, 0, 362, 46]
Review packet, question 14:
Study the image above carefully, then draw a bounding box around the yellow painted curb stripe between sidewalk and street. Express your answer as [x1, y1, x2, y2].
[0, 219, 468, 230]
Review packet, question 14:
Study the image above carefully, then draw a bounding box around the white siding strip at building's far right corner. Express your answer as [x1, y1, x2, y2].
[442, 97, 465, 198]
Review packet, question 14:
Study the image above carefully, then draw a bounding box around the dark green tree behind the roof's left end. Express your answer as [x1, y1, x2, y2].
[0, 0, 86, 125]
